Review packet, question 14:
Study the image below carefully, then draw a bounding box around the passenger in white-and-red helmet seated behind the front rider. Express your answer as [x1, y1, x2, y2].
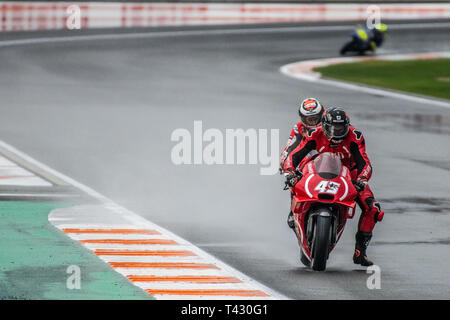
[280, 98, 325, 229]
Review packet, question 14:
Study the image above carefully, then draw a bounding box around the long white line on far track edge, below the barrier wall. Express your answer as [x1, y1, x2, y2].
[0, 22, 450, 47]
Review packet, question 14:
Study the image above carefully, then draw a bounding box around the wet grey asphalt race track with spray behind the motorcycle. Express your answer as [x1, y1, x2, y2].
[0, 24, 450, 299]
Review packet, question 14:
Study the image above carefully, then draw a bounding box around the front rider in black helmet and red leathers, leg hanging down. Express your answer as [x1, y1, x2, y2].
[283, 108, 384, 266]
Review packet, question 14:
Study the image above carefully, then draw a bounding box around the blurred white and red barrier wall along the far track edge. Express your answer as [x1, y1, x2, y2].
[0, 1, 450, 31]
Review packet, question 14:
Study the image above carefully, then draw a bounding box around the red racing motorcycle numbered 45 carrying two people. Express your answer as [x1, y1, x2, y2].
[291, 152, 358, 271]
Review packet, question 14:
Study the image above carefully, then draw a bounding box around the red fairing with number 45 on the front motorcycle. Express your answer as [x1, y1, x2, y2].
[291, 153, 358, 259]
